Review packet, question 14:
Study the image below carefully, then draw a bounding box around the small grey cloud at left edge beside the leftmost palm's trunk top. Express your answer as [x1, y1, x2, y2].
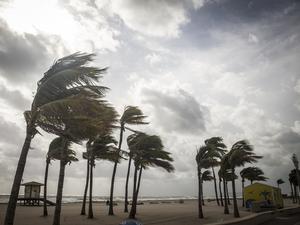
[0, 84, 30, 111]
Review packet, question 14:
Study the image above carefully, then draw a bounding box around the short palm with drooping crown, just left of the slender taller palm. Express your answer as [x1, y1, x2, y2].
[86, 134, 120, 219]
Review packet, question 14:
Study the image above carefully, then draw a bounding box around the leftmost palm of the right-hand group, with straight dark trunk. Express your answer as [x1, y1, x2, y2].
[196, 146, 214, 218]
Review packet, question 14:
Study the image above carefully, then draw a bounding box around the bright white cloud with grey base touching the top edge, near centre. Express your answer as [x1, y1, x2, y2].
[105, 0, 203, 38]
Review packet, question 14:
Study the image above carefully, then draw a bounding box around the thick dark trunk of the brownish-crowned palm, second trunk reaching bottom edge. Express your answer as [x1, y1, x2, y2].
[53, 159, 66, 225]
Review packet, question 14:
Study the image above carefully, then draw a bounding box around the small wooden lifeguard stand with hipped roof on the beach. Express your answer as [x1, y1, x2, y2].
[19, 181, 44, 205]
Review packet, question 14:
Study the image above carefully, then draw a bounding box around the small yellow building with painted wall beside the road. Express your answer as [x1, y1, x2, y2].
[244, 183, 283, 208]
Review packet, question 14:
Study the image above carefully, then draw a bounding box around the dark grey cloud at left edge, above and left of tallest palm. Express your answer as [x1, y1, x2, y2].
[0, 19, 59, 82]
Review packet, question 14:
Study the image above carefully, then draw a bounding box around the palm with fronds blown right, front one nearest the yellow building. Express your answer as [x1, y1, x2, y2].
[228, 140, 262, 217]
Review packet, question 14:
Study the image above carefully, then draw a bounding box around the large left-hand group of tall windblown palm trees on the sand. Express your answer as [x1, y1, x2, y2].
[4, 53, 174, 225]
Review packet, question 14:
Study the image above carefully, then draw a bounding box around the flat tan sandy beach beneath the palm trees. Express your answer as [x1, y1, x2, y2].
[0, 200, 251, 225]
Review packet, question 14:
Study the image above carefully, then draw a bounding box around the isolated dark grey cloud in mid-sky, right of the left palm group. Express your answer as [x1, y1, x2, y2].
[142, 89, 205, 133]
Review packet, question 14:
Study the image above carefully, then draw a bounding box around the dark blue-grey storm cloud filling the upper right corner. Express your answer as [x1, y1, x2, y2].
[178, 0, 300, 49]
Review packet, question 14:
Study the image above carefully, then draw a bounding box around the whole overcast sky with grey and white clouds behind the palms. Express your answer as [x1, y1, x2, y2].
[0, 0, 300, 196]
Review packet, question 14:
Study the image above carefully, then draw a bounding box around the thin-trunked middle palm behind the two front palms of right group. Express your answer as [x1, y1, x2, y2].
[204, 137, 226, 205]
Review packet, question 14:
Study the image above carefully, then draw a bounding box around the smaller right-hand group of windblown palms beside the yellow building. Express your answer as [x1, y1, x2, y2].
[196, 137, 267, 218]
